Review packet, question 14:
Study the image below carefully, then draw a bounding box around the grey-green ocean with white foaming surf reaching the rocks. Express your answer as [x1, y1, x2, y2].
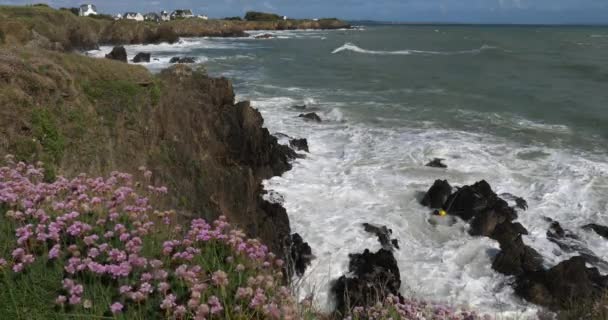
[91, 25, 608, 317]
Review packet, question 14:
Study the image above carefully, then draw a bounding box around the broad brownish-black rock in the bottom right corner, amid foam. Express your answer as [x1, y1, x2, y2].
[515, 257, 608, 310]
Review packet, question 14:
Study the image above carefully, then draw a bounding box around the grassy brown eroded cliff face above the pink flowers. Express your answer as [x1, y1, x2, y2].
[0, 48, 294, 254]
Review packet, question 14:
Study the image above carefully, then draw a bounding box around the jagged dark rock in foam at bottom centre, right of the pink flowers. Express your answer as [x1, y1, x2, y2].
[331, 249, 401, 315]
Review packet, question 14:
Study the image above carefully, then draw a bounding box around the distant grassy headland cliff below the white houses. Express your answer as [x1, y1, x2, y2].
[0, 6, 350, 50]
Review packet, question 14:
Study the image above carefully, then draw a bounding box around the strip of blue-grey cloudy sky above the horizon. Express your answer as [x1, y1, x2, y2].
[0, 0, 608, 24]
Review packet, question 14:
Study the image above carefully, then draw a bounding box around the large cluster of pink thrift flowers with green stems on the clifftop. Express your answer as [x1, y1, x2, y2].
[0, 156, 297, 319]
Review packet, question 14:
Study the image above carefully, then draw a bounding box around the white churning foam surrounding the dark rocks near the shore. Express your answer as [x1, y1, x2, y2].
[242, 93, 608, 316]
